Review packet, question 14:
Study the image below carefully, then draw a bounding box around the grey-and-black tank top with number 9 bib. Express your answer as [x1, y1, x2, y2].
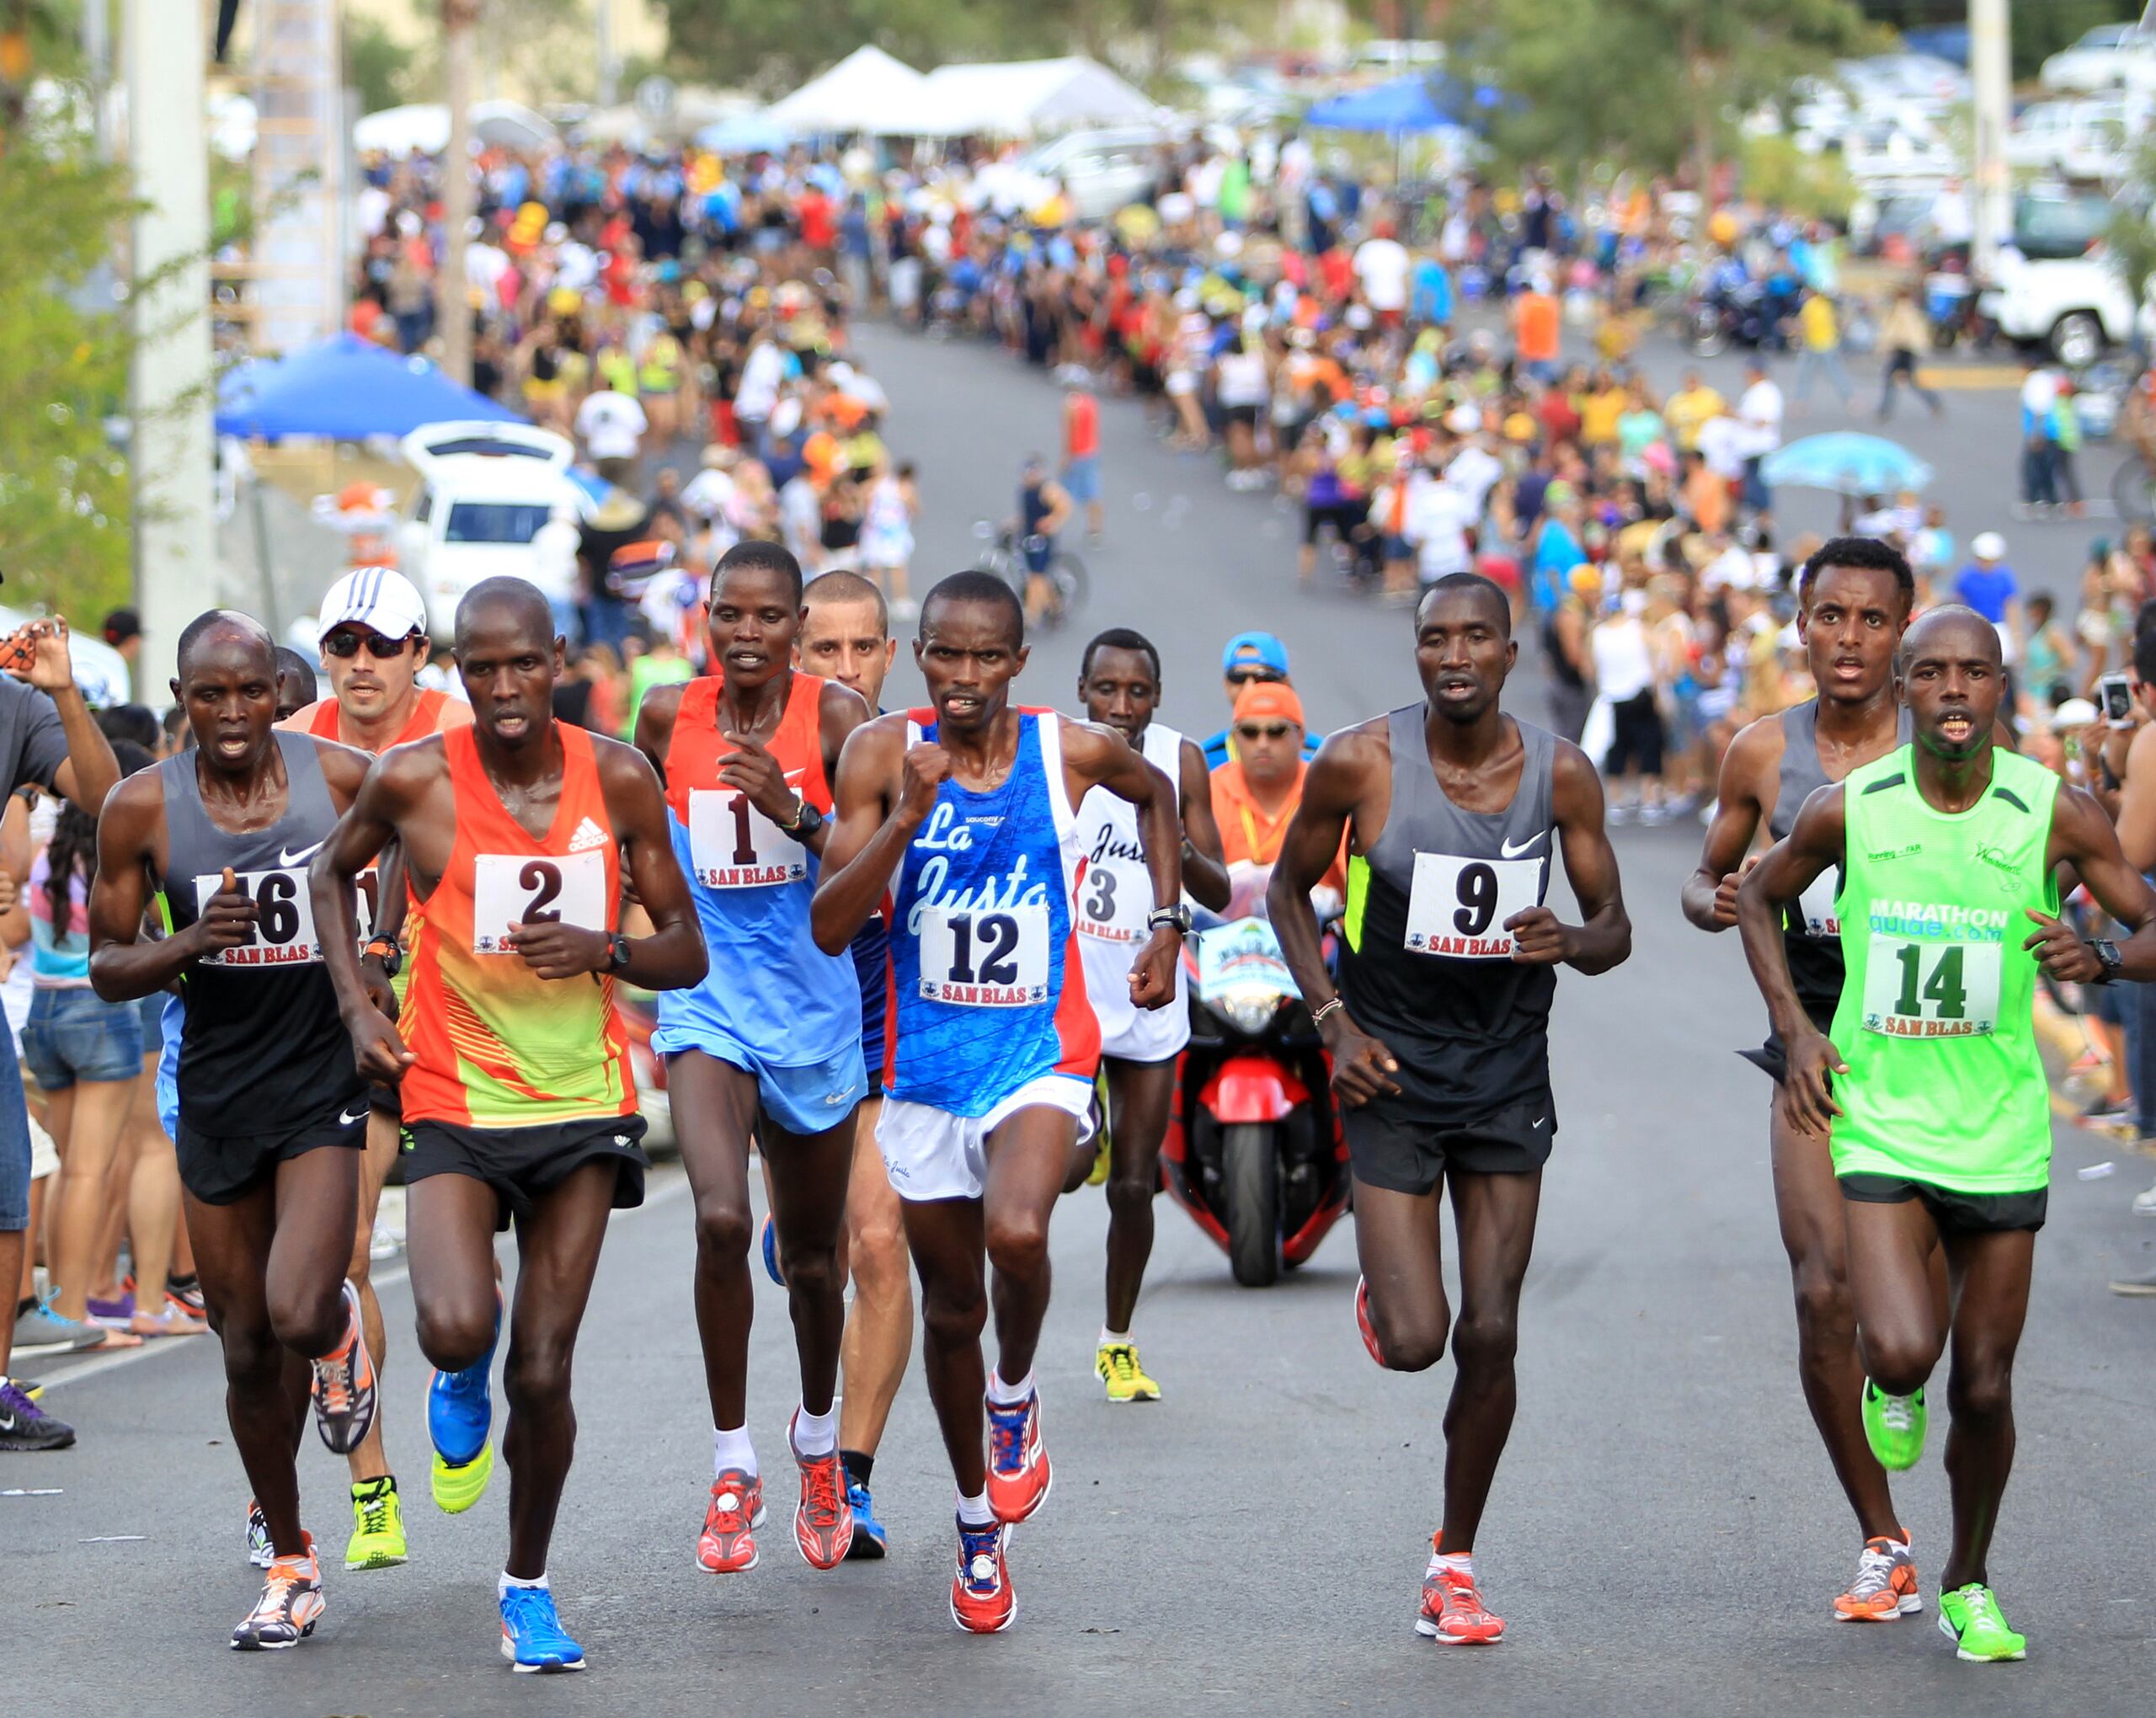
[1341, 705, 1556, 1125]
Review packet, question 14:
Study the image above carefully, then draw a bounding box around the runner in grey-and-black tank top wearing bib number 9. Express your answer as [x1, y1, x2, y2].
[1270, 574, 1632, 1642]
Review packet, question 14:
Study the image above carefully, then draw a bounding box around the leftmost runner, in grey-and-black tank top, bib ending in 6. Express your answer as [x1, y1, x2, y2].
[91, 610, 375, 1651]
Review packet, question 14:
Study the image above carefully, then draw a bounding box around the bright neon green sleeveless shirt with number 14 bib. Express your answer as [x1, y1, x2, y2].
[1833, 746, 2059, 1194]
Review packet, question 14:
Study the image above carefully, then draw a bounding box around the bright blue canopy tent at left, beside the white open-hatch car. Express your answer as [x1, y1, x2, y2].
[218, 334, 524, 442]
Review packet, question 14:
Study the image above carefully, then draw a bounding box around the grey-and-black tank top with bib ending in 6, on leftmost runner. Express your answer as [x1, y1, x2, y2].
[157, 733, 360, 1138]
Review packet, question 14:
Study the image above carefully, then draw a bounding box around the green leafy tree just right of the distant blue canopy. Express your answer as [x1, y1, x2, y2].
[1455, 0, 1870, 183]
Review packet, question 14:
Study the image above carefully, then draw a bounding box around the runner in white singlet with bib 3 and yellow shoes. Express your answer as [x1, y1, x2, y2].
[1078, 627, 1229, 1401]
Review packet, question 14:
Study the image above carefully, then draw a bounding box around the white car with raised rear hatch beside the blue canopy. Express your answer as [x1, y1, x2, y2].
[397, 423, 590, 638]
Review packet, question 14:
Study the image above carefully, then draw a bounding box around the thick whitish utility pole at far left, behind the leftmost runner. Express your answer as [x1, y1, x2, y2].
[123, 0, 224, 701]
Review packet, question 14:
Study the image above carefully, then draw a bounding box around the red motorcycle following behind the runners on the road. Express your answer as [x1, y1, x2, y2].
[1160, 918, 1350, 1289]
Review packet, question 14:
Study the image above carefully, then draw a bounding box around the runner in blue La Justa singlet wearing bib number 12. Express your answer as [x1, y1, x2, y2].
[813, 574, 1188, 1634]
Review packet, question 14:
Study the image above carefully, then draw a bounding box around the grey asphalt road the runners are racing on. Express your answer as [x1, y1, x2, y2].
[17, 321, 2156, 1718]
